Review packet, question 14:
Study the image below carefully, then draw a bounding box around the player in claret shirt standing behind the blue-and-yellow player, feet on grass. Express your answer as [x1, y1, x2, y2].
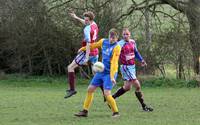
[113, 28, 153, 111]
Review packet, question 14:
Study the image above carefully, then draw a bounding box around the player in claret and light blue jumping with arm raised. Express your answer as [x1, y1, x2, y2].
[64, 11, 98, 98]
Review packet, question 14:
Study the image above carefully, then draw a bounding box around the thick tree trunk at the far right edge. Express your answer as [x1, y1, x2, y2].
[186, 1, 200, 75]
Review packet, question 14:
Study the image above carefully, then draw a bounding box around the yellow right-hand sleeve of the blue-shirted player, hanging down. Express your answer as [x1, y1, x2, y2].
[110, 45, 121, 79]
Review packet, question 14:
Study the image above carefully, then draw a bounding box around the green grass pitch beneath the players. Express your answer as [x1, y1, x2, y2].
[0, 75, 200, 125]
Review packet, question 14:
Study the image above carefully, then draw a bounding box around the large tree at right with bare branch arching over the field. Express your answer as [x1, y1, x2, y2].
[122, 0, 200, 74]
